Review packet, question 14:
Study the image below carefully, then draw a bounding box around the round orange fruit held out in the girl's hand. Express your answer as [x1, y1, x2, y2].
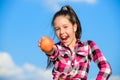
[40, 37, 54, 52]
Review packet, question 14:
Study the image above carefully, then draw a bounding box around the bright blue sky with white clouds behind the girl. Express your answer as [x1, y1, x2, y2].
[0, 0, 120, 80]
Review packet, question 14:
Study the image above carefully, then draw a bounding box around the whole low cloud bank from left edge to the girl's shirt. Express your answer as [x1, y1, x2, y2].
[0, 52, 52, 80]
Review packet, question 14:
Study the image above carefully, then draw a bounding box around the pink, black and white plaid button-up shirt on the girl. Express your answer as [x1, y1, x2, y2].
[49, 40, 112, 80]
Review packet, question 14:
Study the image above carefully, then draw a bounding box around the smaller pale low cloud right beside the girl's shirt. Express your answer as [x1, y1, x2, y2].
[23, 63, 52, 80]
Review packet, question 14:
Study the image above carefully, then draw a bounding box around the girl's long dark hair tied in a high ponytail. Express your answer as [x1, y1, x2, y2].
[46, 5, 82, 68]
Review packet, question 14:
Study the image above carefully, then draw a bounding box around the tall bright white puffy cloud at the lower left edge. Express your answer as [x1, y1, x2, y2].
[0, 53, 23, 78]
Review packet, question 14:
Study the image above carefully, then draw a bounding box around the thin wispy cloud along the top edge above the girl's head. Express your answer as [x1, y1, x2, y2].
[26, 0, 98, 12]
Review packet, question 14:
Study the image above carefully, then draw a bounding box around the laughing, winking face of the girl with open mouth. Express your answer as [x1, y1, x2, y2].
[54, 16, 77, 46]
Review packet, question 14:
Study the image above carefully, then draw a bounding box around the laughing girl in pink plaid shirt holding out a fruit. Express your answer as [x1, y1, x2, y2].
[39, 6, 112, 80]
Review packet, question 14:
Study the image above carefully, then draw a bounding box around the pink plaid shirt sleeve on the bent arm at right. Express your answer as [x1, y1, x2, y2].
[88, 41, 112, 80]
